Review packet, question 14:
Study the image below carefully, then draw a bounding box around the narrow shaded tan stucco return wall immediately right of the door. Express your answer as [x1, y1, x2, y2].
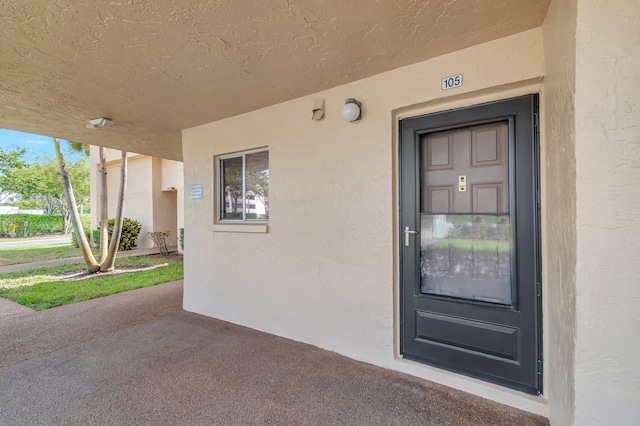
[540, 0, 577, 425]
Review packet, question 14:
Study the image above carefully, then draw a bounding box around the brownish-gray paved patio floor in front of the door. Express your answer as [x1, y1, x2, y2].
[0, 281, 548, 425]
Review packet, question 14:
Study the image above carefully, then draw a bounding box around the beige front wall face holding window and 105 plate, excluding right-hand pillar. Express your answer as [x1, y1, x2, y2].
[183, 28, 543, 412]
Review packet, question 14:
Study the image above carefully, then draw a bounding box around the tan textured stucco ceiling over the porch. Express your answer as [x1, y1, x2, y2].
[0, 0, 549, 159]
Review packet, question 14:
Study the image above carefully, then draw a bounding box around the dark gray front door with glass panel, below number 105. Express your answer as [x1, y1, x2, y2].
[400, 95, 542, 393]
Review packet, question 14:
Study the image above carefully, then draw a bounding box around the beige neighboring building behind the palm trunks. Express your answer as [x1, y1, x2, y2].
[90, 146, 183, 248]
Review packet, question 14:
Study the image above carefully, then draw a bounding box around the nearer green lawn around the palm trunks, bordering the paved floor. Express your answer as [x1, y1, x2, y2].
[0, 255, 183, 311]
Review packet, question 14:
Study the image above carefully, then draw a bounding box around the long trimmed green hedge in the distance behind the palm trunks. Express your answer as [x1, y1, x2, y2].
[0, 214, 90, 237]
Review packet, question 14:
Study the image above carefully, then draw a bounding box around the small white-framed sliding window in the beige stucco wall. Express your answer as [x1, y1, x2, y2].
[218, 150, 269, 221]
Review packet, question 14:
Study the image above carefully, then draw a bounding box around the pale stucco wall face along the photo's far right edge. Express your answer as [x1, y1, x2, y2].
[575, 0, 640, 425]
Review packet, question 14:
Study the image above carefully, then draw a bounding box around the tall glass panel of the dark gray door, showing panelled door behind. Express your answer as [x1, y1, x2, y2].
[420, 122, 514, 305]
